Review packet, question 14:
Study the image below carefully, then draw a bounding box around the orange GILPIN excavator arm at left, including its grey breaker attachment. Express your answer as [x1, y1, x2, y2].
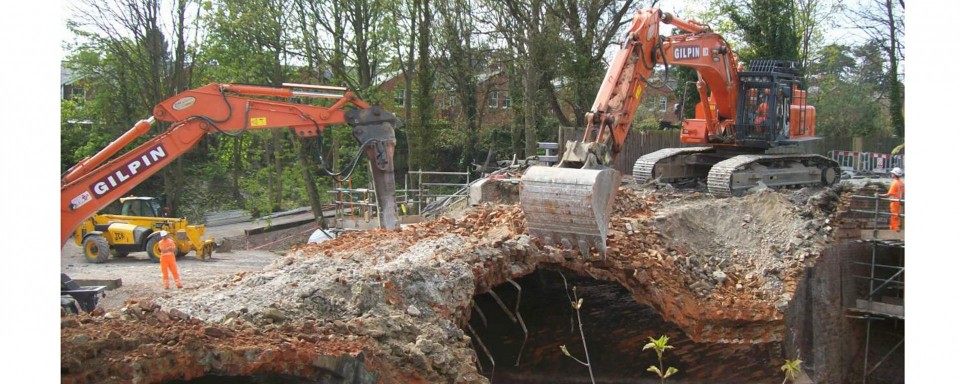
[60, 83, 399, 253]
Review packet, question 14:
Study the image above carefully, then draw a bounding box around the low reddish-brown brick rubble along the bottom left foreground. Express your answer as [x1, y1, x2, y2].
[60, 300, 376, 383]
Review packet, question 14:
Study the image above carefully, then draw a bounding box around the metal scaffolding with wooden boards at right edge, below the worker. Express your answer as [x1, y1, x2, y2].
[848, 195, 906, 383]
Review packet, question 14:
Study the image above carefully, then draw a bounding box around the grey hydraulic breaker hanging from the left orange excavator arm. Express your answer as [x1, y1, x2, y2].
[344, 106, 400, 229]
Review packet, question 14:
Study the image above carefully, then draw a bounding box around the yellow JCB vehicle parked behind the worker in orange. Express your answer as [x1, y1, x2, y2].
[73, 196, 214, 263]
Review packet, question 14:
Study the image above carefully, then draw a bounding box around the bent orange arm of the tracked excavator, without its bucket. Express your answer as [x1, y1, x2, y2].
[559, 8, 739, 168]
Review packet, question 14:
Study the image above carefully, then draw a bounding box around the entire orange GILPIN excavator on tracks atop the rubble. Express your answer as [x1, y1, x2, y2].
[520, 8, 840, 256]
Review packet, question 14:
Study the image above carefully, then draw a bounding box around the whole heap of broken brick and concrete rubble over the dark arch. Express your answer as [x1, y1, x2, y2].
[61, 184, 835, 383]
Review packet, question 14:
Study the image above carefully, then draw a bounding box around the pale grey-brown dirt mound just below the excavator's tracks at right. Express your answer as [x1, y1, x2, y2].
[653, 189, 837, 308]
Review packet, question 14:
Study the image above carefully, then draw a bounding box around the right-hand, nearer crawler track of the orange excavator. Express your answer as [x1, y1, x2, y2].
[707, 154, 840, 197]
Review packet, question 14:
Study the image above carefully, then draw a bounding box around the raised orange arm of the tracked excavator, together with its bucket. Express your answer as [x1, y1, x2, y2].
[520, 8, 738, 256]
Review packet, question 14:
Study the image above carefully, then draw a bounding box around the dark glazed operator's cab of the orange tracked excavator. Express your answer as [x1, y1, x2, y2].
[735, 60, 800, 149]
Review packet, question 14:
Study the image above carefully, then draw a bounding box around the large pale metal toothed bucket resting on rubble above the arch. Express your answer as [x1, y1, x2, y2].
[520, 166, 621, 257]
